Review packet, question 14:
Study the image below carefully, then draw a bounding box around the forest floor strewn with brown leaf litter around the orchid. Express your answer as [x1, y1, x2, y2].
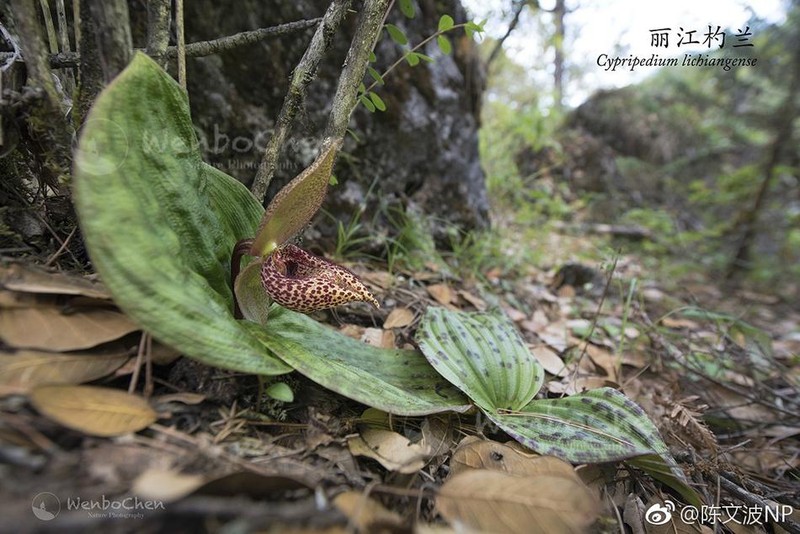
[0, 221, 800, 533]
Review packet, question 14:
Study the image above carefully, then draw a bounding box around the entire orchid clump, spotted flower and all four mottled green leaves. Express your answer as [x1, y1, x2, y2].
[73, 53, 699, 502]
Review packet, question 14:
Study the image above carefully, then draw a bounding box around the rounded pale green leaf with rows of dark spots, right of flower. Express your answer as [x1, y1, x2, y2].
[417, 307, 544, 413]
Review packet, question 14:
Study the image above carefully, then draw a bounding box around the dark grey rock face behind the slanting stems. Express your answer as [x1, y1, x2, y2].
[180, 0, 488, 243]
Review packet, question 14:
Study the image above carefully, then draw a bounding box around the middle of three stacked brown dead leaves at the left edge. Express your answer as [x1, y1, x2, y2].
[0, 306, 139, 352]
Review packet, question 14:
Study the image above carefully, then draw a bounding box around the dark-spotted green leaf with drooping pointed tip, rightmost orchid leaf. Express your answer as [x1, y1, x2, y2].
[486, 388, 699, 502]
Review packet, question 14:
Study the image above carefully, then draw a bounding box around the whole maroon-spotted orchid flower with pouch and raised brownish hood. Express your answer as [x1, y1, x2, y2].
[231, 141, 379, 323]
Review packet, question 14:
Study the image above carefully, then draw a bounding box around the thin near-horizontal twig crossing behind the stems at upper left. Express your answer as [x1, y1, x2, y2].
[0, 17, 322, 69]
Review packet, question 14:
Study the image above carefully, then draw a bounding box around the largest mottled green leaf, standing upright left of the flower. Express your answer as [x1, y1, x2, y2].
[74, 54, 291, 375]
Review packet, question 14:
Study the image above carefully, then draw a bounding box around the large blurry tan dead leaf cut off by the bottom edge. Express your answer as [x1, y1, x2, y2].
[436, 469, 599, 534]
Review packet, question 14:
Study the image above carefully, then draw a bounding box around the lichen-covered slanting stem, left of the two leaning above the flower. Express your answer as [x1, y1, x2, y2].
[250, 0, 352, 202]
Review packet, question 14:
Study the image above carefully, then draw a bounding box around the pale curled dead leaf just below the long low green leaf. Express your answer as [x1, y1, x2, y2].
[347, 428, 432, 474]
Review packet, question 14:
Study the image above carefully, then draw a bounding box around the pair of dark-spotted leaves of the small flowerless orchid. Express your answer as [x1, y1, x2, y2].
[417, 308, 699, 503]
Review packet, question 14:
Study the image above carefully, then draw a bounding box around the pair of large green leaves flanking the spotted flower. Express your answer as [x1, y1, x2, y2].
[74, 54, 476, 415]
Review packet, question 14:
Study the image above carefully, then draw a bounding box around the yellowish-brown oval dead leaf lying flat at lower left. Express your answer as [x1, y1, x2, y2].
[30, 386, 158, 437]
